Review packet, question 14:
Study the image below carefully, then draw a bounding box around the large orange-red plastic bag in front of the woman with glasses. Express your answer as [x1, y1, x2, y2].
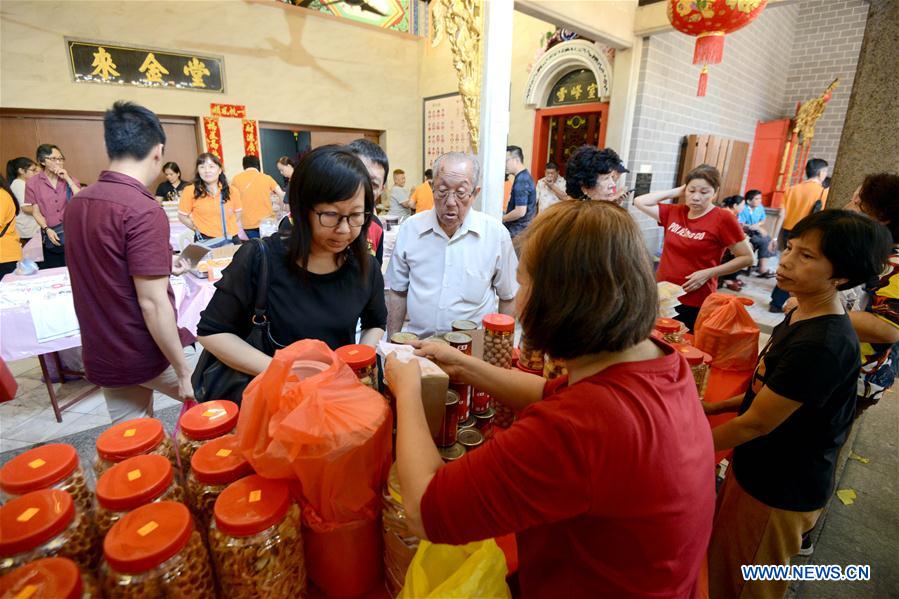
[237, 339, 393, 525]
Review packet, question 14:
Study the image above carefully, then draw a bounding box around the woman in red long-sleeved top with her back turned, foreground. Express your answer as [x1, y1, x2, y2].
[386, 202, 715, 598]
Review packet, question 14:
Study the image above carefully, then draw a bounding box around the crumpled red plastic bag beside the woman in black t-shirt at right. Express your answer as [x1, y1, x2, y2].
[693, 293, 759, 370]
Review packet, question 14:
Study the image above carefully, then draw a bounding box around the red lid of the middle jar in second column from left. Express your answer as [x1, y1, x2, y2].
[97, 455, 174, 512]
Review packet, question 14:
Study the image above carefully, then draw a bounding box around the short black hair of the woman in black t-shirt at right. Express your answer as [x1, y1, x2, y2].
[790, 210, 893, 291]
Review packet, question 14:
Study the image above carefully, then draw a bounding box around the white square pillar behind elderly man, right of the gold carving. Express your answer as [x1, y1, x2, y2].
[478, 0, 514, 218]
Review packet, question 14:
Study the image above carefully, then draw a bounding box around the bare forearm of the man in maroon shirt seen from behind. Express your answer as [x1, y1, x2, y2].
[132, 276, 194, 401]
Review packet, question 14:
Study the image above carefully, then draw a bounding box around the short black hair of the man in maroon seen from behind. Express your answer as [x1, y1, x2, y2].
[103, 101, 165, 160]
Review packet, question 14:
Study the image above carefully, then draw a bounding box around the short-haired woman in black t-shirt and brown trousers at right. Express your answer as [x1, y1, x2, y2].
[704, 210, 892, 598]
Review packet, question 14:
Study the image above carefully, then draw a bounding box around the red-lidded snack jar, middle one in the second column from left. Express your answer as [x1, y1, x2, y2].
[96, 455, 184, 535]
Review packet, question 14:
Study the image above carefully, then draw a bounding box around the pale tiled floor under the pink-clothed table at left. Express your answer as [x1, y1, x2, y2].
[0, 358, 178, 453]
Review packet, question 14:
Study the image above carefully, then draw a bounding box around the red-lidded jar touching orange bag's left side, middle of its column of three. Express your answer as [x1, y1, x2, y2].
[187, 435, 253, 530]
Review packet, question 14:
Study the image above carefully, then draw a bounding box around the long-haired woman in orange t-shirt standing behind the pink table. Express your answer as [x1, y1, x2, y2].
[178, 152, 243, 243]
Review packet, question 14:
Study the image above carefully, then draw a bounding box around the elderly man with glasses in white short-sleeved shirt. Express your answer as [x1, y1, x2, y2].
[387, 152, 518, 337]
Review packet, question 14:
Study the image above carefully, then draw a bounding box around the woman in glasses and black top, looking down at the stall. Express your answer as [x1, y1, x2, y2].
[197, 145, 387, 376]
